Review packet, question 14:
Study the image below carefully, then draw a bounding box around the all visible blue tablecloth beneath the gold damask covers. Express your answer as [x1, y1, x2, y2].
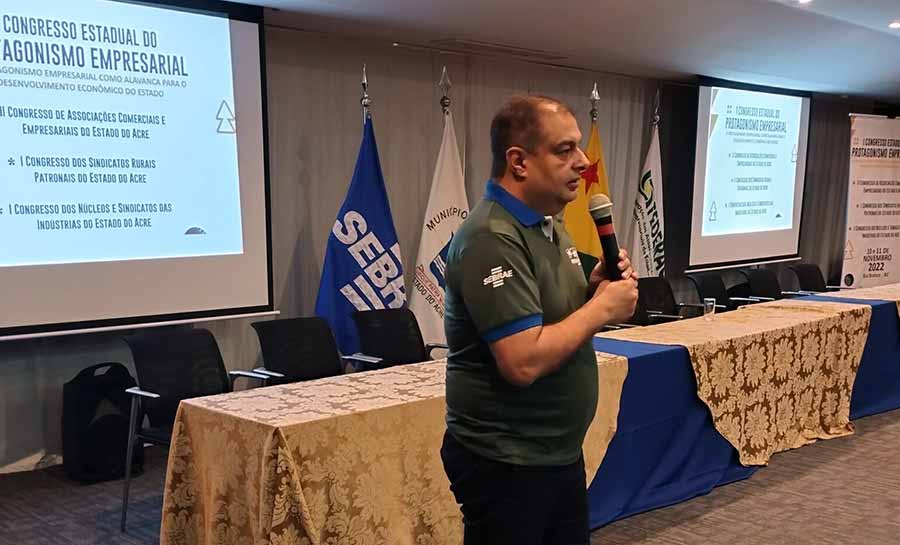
[588, 296, 900, 528]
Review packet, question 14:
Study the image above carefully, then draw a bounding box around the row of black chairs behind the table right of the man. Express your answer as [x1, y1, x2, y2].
[622, 263, 838, 327]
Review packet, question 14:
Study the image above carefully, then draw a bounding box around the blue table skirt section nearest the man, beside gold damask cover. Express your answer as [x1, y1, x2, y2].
[588, 338, 756, 528]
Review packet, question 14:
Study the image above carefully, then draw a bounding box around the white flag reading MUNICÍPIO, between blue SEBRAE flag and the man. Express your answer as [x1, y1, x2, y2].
[409, 112, 469, 343]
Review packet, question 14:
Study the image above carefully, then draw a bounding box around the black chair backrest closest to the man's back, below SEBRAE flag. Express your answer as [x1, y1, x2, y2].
[353, 308, 429, 367]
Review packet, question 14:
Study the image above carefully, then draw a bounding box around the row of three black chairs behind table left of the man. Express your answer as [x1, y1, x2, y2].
[120, 308, 446, 532]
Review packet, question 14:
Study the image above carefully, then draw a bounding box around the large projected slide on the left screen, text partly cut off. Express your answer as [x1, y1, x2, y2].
[0, 0, 243, 266]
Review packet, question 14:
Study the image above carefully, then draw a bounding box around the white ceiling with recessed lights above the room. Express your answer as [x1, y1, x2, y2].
[251, 0, 900, 103]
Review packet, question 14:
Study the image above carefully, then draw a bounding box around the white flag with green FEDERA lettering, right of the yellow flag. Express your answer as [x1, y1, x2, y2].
[629, 125, 666, 277]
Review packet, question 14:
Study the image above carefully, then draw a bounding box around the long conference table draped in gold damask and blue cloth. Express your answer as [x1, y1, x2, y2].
[160, 285, 900, 545]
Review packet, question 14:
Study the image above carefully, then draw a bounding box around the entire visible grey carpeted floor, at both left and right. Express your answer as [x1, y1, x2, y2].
[0, 411, 900, 545]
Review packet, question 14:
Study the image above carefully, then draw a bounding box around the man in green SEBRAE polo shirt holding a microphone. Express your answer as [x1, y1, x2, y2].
[441, 96, 637, 545]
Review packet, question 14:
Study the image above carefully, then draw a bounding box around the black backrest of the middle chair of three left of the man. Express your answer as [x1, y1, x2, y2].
[250, 316, 344, 384]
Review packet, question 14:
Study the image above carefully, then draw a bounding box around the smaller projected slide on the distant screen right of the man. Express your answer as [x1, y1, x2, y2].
[702, 87, 803, 237]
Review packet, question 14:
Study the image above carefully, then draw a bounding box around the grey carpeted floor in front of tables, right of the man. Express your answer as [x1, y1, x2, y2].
[591, 410, 900, 545]
